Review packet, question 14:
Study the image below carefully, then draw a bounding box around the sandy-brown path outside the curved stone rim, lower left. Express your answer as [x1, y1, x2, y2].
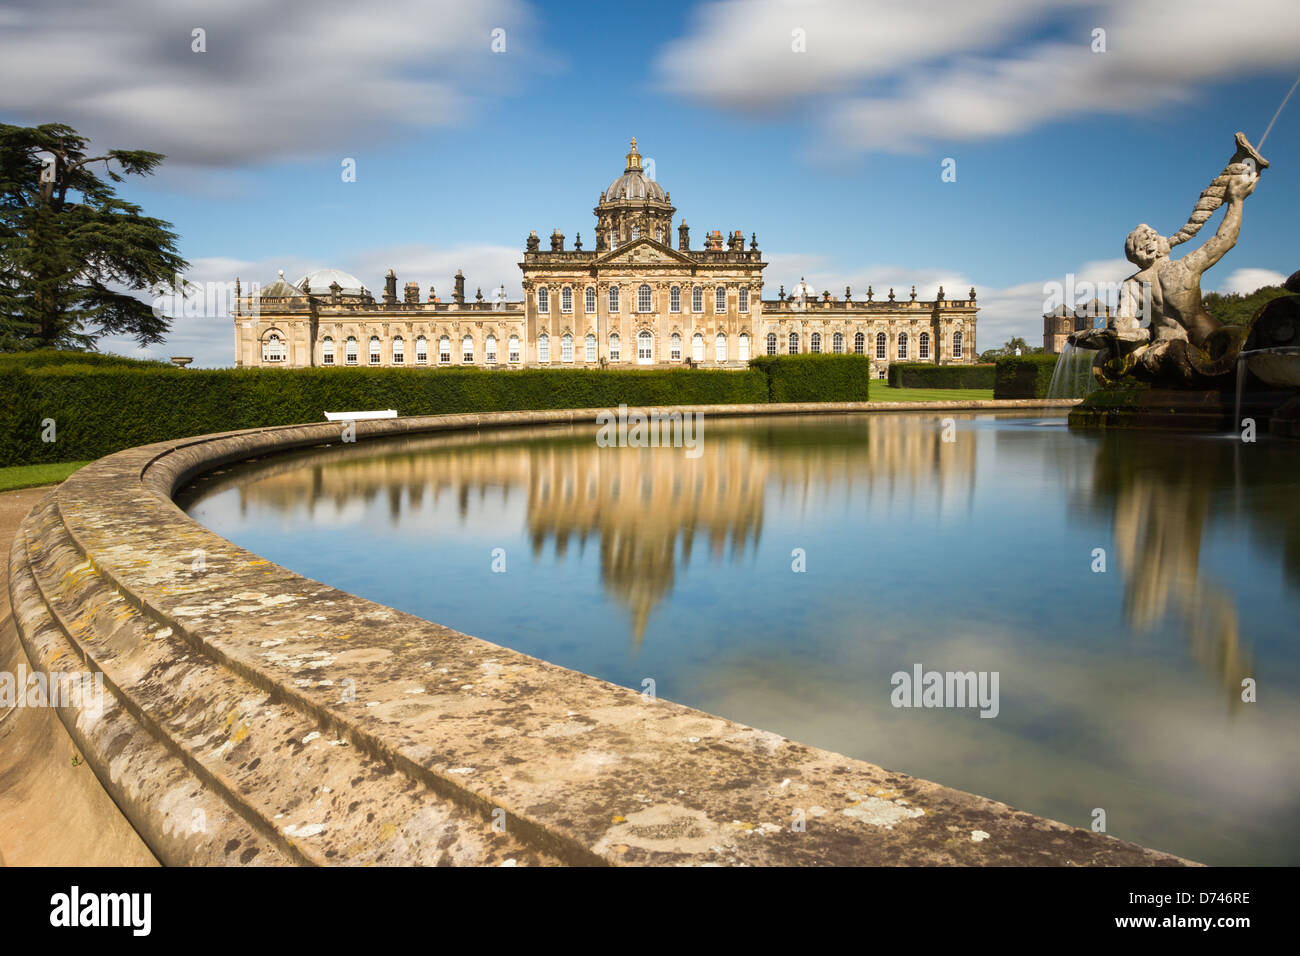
[0, 488, 157, 866]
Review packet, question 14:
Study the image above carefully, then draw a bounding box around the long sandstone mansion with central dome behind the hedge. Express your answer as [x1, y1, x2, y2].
[234, 139, 979, 377]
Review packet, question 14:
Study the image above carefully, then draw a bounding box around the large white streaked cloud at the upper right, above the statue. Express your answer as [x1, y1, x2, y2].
[657, 0, 1300, 152]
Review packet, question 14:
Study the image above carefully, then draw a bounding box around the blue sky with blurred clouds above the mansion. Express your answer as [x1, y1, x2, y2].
[0, 0, 1300, 364]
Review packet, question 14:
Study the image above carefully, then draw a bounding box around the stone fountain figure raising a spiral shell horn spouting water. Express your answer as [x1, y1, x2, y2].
[1069, 133, 1269, 388]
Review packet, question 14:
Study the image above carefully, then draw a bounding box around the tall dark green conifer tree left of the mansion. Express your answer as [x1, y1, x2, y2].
[0, 124, 189, 351]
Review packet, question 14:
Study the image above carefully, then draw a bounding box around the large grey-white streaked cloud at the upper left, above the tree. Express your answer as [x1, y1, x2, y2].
[0, 0, 540, 166]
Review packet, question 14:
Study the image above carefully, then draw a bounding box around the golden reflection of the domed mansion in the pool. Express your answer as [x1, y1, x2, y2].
[228, 416, 975, 637]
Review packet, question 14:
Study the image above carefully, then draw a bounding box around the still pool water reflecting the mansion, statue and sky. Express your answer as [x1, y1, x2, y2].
[181, 414, 1300, 865]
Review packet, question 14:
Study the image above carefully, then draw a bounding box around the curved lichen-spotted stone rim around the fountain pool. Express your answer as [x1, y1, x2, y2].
[10, 401, 1187, 865]
